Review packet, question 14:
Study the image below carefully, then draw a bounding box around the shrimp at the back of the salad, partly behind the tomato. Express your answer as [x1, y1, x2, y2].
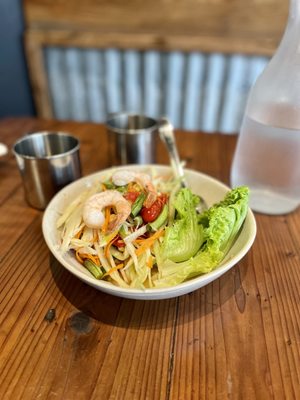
[112, 169, 157, 207]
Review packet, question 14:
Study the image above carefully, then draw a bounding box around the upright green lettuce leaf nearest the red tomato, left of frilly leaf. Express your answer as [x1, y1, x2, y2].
[160, 188, 204, 262]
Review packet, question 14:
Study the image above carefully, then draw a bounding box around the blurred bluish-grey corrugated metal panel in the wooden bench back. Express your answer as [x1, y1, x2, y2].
[45, 47, 268, 133]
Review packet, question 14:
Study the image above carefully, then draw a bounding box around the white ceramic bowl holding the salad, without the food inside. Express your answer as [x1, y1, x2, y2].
[42, 165, 256, 300]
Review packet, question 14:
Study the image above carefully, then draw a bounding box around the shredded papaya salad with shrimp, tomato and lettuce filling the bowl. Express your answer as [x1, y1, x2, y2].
[57, 168, 249, 289]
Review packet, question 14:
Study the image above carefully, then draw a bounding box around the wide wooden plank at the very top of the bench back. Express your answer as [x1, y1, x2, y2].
[24, 0, 288, 55]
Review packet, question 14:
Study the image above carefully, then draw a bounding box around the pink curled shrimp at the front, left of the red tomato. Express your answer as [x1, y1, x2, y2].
[83, 190, 131, 232]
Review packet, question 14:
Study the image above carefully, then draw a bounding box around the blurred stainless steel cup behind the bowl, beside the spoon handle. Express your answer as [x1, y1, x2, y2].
[106, 113, 158, 165]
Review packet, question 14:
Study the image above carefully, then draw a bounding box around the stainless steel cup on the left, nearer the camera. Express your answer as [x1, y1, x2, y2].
[13, 132, 81, 210]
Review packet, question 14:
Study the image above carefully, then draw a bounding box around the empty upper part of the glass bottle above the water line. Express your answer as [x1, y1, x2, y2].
[246, 0, 300, 130]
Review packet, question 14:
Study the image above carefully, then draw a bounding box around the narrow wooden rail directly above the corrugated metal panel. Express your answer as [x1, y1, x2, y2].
[25, 27, 279, 56]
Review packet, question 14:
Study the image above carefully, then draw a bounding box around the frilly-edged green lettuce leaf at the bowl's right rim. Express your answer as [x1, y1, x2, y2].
[155, 186, 249, 287]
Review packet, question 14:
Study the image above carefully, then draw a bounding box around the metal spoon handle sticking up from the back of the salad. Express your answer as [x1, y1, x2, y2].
[159, 118, 187, 187]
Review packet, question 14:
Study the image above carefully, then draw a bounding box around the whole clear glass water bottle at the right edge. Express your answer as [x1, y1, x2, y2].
[231, 0, 300, 214]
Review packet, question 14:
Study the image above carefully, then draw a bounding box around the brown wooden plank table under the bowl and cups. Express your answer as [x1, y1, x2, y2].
[0, 119, 300, 400]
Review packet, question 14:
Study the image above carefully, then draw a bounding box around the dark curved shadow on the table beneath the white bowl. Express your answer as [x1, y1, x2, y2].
[49, 255, 247, 330]
